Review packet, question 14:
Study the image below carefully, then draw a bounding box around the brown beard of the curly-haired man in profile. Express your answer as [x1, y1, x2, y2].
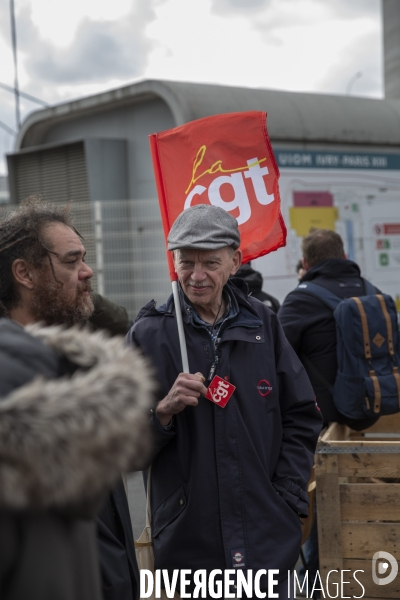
[32, 274, 94, 327]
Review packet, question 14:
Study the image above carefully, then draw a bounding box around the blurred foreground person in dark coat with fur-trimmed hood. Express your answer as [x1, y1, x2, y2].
[0, 318, 152, 600]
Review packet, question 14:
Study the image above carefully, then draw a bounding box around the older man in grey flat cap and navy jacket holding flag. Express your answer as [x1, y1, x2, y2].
[128, 205, 321, 598]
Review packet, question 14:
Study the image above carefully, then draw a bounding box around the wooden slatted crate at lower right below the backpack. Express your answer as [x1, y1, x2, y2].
[316, 414, 400, 600]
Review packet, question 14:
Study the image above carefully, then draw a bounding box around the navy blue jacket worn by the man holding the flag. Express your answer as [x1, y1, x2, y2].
[128, 282, 322, 578]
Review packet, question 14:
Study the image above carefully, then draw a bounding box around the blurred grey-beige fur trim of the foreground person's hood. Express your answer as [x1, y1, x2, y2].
[0, 322, 153, 512]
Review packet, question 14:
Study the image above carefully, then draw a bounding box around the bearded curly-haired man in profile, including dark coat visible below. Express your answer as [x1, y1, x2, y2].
[0, 198, 139, 600]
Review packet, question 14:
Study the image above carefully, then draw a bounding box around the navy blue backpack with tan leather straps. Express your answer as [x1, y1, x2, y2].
[296, 280, 400, 419]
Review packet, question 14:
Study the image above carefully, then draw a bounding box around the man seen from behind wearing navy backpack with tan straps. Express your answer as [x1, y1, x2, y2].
[278, 229, 400, 596]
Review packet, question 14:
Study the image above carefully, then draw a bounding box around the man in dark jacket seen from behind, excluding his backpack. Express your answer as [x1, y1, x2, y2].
[278, 229, 377, 597]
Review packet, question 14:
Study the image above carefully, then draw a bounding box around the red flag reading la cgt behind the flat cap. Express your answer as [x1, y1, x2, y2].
[150, 111, 286, 280]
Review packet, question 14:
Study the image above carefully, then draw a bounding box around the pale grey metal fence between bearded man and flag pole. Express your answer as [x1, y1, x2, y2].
[0, 199, 171, 319]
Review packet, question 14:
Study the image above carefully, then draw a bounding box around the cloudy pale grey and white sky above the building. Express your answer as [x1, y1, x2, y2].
[0, 0, 383, 174]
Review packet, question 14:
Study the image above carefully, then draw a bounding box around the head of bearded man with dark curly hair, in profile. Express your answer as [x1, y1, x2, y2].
[0, 199, 94, 326]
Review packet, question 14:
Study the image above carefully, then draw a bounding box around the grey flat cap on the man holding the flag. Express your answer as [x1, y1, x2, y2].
[168, 204, 240, 250]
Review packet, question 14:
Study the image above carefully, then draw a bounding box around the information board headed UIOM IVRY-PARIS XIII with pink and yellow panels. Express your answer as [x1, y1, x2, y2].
[253, 149, 400, 311]
